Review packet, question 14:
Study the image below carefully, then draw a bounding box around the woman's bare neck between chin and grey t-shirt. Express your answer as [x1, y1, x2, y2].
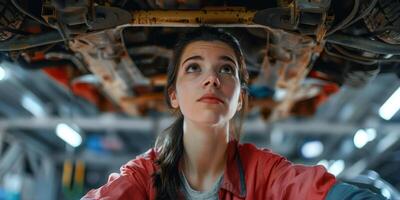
[182, 119, 229, 190]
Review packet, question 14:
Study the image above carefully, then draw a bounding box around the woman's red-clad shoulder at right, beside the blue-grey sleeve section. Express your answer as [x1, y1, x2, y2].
[239, 144, 336, 199]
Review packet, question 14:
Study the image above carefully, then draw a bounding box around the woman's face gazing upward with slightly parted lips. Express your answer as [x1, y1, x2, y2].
[169, 41, 242, 125]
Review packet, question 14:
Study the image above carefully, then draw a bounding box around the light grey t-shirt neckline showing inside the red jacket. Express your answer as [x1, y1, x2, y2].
[180, 172, 223, 200]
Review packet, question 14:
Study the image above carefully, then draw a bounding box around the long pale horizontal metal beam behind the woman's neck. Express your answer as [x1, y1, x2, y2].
[0, 117, 400, 135]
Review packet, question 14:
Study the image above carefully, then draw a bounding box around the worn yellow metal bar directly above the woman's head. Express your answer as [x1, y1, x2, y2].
[131, 7, 263, 27]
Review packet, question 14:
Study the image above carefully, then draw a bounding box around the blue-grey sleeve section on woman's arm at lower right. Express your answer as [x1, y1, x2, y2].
[326, 182, 386, 200]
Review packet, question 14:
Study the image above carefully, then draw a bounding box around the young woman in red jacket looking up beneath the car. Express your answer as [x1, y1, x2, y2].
[82, 28, 388, 200]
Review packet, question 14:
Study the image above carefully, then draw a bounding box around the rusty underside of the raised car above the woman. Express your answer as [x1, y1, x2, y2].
[0, 0, 400, 120]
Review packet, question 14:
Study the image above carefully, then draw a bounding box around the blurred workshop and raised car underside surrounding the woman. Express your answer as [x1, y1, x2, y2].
[0, 0, 400, 200]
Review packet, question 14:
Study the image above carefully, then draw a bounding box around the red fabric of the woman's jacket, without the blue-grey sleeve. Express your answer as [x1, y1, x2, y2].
[82, 141, 336, 200]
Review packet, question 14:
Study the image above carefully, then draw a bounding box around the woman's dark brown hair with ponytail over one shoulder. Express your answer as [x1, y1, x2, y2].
[153, 27, 249, 200]
